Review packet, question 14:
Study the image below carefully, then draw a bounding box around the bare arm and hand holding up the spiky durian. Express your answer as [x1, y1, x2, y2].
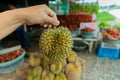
[0, 5, 60, 40]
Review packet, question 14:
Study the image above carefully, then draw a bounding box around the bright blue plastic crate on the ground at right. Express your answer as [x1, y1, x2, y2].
[97, 45, 120, 60]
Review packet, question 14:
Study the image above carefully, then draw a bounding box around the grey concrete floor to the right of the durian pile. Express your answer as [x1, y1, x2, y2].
[78, 53, 120, 80]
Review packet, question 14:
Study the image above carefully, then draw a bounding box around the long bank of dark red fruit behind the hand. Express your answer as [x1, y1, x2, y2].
[57, 12, 92, 31]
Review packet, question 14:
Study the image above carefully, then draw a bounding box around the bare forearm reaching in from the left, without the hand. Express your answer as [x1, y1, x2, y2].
[0, 9, 25, 40]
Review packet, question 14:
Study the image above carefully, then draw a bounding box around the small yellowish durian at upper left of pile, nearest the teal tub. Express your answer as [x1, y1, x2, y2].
[29, 55, 41, 67]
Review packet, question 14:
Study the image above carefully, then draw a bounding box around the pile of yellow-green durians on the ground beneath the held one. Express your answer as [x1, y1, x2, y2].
[15, 51, 85, 80]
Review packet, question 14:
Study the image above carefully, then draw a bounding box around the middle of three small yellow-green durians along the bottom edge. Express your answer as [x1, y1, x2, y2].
[40, 70, 55, 80]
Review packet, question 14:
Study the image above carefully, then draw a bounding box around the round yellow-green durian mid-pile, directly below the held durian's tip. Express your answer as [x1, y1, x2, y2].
[50, 62, 62, 74]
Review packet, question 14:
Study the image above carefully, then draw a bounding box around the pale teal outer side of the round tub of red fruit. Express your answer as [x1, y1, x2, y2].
[0, 45, 25, 74]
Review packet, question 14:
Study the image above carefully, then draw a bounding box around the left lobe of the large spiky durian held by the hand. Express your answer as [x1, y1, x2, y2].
[39, 28, 55, 56]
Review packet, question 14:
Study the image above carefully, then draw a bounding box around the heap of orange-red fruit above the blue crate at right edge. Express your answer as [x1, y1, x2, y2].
[101, 28, 120, 40]
